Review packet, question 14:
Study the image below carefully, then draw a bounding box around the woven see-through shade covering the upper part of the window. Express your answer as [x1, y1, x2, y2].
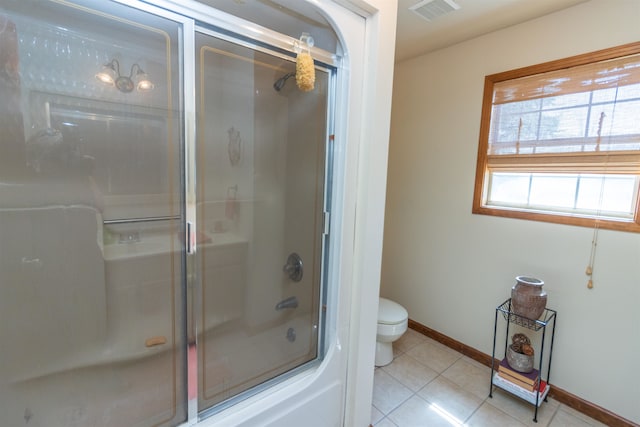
[480, 43, 640, 174]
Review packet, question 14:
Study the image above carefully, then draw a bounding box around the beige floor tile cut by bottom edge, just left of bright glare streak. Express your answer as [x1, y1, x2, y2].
[387, 395, 462, 427]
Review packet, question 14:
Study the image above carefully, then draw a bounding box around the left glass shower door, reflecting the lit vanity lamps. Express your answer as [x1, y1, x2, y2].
[0, 0, 187, 427]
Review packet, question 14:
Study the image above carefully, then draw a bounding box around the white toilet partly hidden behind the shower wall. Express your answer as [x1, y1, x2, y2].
[375, 298, 409, 366]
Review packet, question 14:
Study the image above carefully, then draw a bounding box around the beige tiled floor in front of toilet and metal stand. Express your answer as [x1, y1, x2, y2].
[371, 329, 604, 427]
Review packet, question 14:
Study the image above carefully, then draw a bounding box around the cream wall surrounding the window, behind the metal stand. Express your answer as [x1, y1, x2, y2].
[381, 0, 640, 423]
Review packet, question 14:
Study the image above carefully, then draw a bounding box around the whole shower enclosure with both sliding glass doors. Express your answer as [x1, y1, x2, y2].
[0, 0, 336, 427]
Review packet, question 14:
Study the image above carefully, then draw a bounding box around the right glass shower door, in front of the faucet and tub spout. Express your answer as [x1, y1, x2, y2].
[195, 30, 329, 410]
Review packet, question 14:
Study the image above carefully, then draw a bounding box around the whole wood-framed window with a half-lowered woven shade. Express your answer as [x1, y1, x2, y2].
[473, 43, 640, 232]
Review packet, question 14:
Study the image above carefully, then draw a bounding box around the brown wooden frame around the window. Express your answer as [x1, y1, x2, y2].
[472, 42, 640, 233]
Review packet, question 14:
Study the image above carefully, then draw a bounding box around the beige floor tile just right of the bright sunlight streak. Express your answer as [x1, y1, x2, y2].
[418, 375, 484, 423]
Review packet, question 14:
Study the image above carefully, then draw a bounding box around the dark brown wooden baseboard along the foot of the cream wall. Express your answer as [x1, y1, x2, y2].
[409, 319, 639, 427]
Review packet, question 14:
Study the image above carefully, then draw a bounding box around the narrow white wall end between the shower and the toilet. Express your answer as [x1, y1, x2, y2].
[332, 0, 398, 427]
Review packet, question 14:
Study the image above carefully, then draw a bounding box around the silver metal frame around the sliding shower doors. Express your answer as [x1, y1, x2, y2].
[117, 0, 342, 425]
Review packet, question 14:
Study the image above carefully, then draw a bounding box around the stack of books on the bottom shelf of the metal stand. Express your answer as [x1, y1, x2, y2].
[493, 359, 550, 406]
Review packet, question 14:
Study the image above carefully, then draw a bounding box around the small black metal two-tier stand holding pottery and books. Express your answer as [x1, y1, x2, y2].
[489, 298, 557, 423]
